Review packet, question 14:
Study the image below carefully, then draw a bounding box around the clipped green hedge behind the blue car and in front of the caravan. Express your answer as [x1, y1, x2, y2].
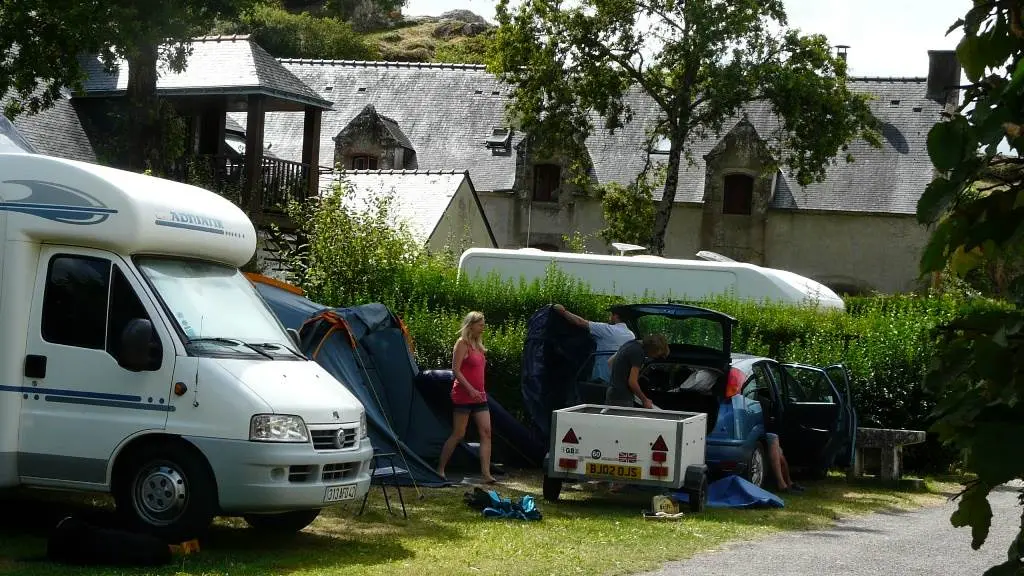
[390, 270, 997, 470]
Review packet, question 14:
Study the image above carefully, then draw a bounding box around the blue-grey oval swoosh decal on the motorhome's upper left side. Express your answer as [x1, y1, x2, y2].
[0, 180, 118, 224]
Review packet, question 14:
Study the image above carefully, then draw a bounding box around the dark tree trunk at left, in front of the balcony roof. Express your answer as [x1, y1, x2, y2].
[126, 44, 163, 172]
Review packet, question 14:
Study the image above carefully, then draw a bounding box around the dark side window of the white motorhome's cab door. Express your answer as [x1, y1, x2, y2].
[42, 255, 148, 358]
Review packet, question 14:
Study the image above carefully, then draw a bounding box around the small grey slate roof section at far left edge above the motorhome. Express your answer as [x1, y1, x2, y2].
[0, 94, 97, 164]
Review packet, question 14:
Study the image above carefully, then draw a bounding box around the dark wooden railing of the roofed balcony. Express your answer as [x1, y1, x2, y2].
[173, 155, 319, 213]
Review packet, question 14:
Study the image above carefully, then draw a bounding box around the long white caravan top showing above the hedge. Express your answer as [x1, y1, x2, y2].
[459, 248, 846, 310]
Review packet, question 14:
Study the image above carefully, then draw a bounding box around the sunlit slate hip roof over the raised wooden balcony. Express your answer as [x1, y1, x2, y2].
[83, 35, 331, 109]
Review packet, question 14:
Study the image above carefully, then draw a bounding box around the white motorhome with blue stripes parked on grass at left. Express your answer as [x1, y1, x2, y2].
[0, 154, 373, 540]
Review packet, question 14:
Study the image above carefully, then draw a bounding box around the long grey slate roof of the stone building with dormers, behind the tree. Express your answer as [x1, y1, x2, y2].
[256, 59, 943, 214]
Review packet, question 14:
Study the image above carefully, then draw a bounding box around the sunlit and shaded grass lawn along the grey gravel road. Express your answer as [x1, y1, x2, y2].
[0, 471, 953, 576]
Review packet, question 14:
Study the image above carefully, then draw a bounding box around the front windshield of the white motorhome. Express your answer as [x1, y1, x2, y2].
[137, 258, 297, 359]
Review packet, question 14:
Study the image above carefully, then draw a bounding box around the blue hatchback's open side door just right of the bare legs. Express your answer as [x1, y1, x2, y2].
[779, 364, 845, 474]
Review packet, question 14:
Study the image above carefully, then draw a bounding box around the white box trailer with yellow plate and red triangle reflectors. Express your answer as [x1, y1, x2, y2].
[544, 404, 708, 511]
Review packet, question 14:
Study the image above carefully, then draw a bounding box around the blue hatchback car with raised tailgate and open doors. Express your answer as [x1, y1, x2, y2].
[577, 303, 857, 486]
